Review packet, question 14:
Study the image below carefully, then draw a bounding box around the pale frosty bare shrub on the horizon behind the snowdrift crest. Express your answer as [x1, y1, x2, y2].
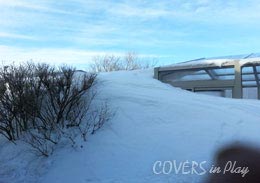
[90, 52, 157, 72]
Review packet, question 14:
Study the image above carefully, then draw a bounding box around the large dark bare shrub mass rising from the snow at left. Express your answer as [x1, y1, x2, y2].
[0, 63, 109, 156]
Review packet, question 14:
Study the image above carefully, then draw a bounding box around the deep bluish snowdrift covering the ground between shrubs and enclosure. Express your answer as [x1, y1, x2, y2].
[0, 70, 260, 183]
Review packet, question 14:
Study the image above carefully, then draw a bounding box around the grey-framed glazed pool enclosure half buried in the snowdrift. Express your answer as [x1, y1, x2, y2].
[154, 54, 260, 99]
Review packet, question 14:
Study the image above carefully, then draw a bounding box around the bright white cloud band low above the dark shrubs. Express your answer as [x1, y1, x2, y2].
[0, 45, 158, 67]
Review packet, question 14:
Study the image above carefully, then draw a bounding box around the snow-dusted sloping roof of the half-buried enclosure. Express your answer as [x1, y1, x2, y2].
[161, 53, 260, 69]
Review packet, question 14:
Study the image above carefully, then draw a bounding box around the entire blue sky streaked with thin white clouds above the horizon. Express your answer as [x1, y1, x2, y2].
[0, 0, 260, 65]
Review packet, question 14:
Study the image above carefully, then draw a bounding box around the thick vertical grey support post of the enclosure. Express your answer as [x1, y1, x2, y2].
[232, 61, 243, 98]
